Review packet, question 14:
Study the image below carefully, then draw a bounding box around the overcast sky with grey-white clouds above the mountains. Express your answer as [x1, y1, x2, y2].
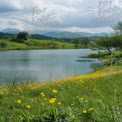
[0, 0, 122, 33]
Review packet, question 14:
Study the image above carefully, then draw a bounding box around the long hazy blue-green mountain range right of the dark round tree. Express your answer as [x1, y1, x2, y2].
[43, 31, 109, 38]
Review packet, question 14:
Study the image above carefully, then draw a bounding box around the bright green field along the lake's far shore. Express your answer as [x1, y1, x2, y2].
[0, 39, 78, 50]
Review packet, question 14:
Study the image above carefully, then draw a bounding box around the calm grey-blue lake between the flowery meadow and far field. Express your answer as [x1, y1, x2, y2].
[0, 49, 102, 82]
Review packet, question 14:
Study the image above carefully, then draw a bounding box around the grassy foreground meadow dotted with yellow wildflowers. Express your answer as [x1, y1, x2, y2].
[0, 66, 122, 122]
